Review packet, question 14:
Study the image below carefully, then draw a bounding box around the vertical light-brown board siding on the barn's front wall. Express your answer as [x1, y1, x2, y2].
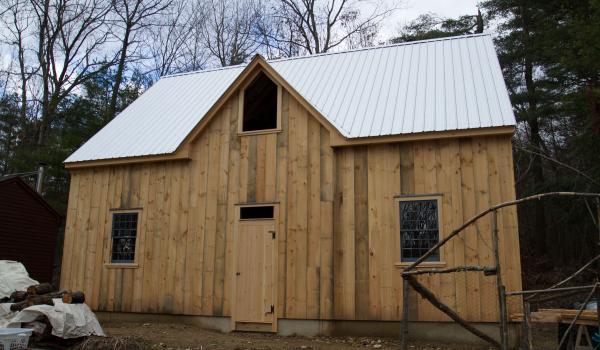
[61, 87, 521, 321]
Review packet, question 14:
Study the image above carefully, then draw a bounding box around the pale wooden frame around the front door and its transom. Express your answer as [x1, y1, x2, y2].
[230, 202, 281, 333]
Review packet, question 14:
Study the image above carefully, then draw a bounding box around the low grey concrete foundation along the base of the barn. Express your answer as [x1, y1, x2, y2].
[96, 312, 520, 349]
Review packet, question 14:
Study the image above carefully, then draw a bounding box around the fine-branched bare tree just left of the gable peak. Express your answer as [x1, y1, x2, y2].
[194, 0, 262, 67]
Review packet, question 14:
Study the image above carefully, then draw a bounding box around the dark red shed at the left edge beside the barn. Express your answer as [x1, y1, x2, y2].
[0, 176, 62, 282]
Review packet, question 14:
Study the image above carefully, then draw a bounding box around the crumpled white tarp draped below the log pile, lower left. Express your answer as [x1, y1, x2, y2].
[0, 299, 105, 339]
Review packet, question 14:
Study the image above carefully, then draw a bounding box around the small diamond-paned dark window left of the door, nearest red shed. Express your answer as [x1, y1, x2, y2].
[111, 213, 138, 263]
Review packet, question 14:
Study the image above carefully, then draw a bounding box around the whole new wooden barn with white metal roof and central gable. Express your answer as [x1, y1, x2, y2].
[61, 35, 521, 337]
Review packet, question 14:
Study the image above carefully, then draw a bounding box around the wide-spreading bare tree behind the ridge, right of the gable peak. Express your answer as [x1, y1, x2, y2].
[261, 0, 396, 55]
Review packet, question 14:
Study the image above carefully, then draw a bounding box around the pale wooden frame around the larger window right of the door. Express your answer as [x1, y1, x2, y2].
[394, 193, 446, 267]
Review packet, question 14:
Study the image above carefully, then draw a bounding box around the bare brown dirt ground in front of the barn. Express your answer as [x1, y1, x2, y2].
[103, 323, 488, 350]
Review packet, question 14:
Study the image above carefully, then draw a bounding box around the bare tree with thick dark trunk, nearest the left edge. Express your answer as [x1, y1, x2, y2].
[30, 0, 116, 146]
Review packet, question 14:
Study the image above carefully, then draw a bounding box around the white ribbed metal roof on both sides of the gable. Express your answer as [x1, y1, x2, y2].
[65, 34, 515, 162]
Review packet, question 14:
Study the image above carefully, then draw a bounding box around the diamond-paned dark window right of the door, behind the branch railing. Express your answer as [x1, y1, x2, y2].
[400, 199, 440, 262]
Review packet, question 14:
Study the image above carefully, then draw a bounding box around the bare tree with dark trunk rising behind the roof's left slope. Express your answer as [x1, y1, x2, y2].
[104, 0, 172, 121]
